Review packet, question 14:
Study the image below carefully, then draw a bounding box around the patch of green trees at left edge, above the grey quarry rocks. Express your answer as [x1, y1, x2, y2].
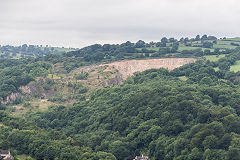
[0, 59, 52, 99]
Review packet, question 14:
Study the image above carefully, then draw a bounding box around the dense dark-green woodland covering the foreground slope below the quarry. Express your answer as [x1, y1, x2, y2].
[0, 52, 240, 160]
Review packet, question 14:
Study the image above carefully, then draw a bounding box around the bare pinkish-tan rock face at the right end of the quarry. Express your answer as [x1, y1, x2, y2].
[102, 58, 196, 79]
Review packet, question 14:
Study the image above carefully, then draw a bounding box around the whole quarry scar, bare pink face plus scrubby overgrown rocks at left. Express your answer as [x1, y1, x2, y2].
[2, 58, 195, 114]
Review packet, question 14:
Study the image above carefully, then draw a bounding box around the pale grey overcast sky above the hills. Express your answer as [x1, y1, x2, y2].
[0, 0, 240, 47]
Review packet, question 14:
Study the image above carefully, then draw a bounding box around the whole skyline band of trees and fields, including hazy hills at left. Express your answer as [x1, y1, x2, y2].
[0, 35, 232, 72]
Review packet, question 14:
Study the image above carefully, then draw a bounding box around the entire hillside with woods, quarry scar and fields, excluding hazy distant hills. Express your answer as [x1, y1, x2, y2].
[0, 35, 240, 160]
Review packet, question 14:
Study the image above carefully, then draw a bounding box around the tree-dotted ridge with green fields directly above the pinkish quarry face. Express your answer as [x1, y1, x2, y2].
[55, 35, 232, 72]
